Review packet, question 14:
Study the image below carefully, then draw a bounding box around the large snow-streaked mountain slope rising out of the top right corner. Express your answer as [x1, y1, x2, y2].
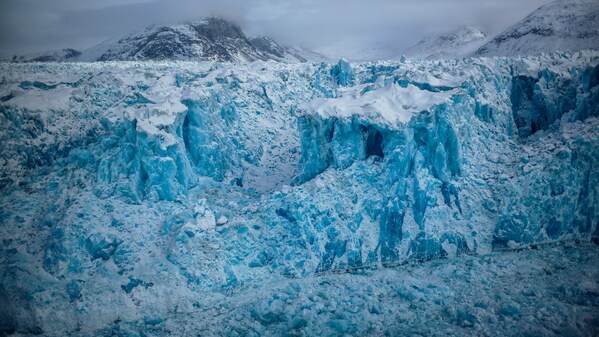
[475, 0, 599, 56]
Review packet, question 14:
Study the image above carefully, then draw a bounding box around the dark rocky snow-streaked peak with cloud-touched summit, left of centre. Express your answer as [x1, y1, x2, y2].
[79, 17, 304, 62]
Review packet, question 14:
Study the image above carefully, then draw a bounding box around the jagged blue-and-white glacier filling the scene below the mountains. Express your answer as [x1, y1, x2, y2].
[0, 51, 599, 336]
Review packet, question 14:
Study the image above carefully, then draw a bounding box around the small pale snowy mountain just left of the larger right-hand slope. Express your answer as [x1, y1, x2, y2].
[404, 26, 487, 59]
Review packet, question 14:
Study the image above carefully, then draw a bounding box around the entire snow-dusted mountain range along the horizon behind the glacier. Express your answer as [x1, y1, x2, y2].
[6, 0, 599, 62]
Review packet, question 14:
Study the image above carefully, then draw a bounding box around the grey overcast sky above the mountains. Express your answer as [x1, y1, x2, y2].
[0, 0, 550, 57]
